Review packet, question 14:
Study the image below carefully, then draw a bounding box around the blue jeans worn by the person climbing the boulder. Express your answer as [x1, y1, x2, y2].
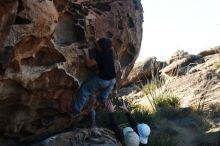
[72, 76, 116, 113]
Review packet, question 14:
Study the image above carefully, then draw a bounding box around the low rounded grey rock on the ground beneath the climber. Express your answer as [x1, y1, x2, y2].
[31, 128, 121, 146]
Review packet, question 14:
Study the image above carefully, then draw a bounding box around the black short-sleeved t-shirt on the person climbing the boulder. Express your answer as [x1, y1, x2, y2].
[89, 49, 116, 80]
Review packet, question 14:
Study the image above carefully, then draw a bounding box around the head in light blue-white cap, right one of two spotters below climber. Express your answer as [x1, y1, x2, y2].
[137, 123, 150, 144]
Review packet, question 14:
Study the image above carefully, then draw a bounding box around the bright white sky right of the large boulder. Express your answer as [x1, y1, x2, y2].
[138, 0, 220, 61]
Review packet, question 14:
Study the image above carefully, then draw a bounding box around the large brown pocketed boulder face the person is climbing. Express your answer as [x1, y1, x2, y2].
[0, 0, 143, 141]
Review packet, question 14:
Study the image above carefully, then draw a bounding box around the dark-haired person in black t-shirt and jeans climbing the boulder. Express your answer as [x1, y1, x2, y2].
[69, 38, 116, 121]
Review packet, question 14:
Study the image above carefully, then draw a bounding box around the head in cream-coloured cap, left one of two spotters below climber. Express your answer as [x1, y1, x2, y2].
[123, 127, 140, 146]
